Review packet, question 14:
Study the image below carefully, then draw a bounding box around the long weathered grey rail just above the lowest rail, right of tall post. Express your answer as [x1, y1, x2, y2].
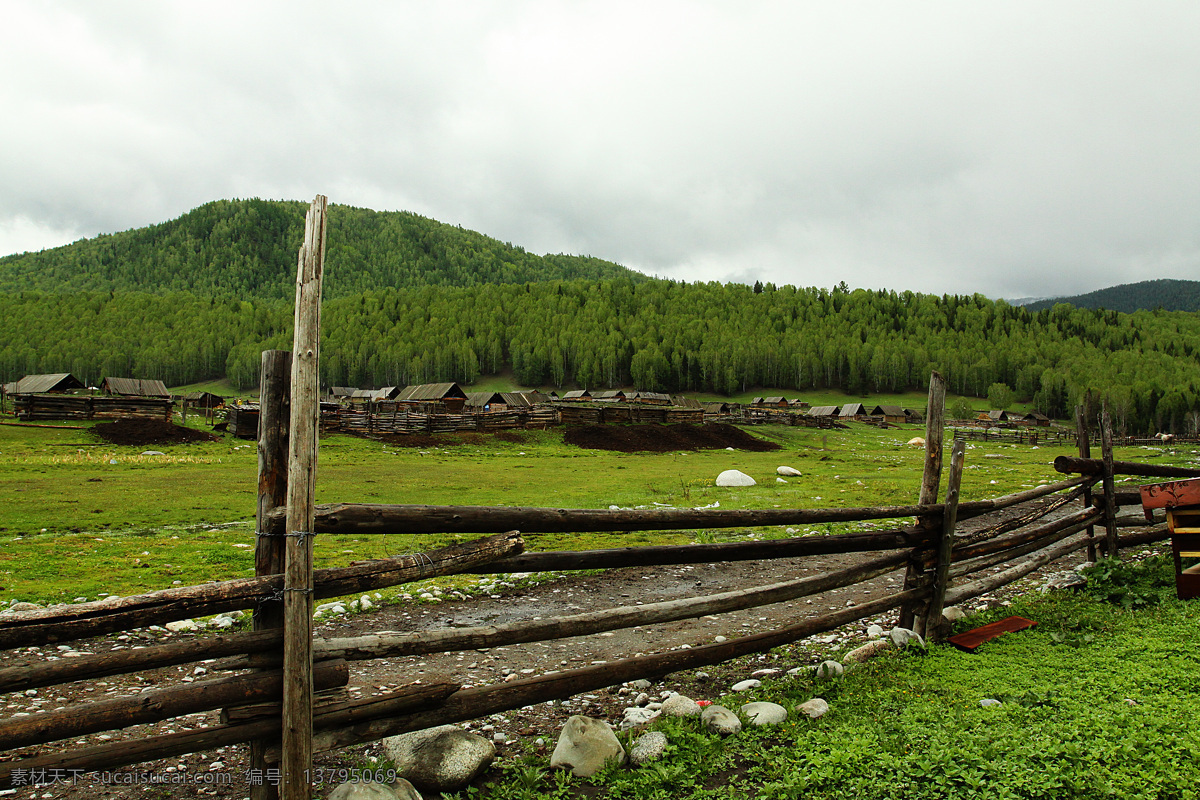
[222, 553, 907, 669]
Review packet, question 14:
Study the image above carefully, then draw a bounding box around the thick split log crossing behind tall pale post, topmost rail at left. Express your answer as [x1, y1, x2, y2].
[0, 531, 524, 648]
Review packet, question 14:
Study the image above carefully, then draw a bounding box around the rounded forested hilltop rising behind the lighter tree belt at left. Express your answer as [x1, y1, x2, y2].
[0, 199, 646, 299]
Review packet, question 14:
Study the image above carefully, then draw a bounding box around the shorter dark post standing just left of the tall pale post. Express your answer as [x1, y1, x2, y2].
[250, 350, 292, 800]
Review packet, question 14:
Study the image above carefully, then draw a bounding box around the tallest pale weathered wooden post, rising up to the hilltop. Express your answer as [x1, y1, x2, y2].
[280, 194, 325, 800]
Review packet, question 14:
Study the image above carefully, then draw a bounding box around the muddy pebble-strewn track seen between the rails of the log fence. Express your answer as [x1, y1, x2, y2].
[0, 501, 1104, 800]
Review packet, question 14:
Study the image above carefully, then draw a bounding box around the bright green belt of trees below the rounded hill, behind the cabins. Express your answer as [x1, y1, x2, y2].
[0, 280, 1200, 432]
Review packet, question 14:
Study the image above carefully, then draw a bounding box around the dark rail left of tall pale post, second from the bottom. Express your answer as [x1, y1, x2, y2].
[0, 660, 350, 750]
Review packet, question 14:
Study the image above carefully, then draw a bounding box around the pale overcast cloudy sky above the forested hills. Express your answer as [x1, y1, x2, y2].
[0, 0, 1200, 297]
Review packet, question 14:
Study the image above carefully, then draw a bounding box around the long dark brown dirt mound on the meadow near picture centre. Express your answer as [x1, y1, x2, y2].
[563, 422, 779, 452]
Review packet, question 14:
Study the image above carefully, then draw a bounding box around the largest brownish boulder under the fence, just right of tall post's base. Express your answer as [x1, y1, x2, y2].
[383, 724, 496, 792]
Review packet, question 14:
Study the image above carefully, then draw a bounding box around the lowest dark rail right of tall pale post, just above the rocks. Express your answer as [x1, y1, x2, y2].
[283, 589, 928, 751]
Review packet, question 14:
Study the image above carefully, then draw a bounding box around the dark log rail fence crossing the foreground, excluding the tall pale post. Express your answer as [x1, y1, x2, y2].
[0, 388, 1196, 787]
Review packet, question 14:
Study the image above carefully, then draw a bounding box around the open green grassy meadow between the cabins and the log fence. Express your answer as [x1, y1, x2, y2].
[0, 412, 1194, 602]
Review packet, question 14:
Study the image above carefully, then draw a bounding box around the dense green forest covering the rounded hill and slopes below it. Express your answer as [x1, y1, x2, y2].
[0, 200, 1200, 432]
